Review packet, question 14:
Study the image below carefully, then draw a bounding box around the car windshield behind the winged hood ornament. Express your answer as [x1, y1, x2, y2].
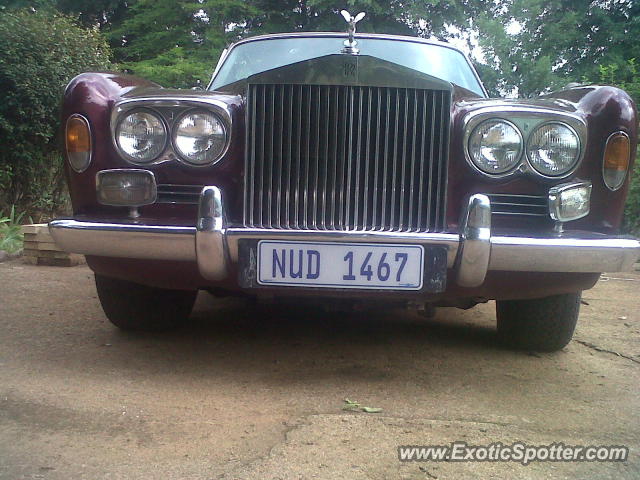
[211, 37, 485, 97]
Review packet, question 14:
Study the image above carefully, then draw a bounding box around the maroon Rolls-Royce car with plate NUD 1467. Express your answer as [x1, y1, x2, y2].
[49, 33, 640, 350]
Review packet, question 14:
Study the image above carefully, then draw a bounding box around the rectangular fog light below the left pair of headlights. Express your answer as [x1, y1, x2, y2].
[96, 169, 158, 207]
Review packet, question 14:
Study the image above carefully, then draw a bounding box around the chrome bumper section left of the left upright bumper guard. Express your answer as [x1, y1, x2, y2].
[49, 220, 196, 261]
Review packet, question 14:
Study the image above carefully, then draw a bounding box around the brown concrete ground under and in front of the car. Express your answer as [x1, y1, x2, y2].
[0, 260, 640, 480]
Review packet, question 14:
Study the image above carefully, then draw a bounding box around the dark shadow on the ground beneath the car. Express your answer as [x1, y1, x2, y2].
[104, 293, 503, 363]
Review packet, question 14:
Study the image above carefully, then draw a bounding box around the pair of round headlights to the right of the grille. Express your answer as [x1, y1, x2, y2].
[467, 118, 581, 177]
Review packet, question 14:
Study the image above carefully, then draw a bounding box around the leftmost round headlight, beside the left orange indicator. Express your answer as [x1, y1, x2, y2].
[116, 110, 167, 163]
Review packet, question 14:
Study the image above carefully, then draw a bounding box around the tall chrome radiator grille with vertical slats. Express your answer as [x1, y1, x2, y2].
[244, 84, 450, 232]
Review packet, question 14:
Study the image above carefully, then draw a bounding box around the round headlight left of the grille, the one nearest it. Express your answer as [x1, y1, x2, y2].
[173, 112, 227, 165]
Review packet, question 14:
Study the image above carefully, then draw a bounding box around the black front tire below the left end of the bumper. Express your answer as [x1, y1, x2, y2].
[95, 275, 198, 332]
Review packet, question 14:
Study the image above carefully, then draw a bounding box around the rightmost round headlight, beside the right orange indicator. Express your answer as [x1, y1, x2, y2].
[527, 123, 580, 177]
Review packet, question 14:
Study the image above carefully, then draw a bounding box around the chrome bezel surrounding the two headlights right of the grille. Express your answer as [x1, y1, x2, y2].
[463, 105, 587, 182]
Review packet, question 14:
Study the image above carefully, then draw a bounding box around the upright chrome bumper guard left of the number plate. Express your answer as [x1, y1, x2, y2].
[195, 187, 228, 281]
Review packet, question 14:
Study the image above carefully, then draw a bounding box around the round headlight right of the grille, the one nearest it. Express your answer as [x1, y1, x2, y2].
[468, 119, 522, 174]
